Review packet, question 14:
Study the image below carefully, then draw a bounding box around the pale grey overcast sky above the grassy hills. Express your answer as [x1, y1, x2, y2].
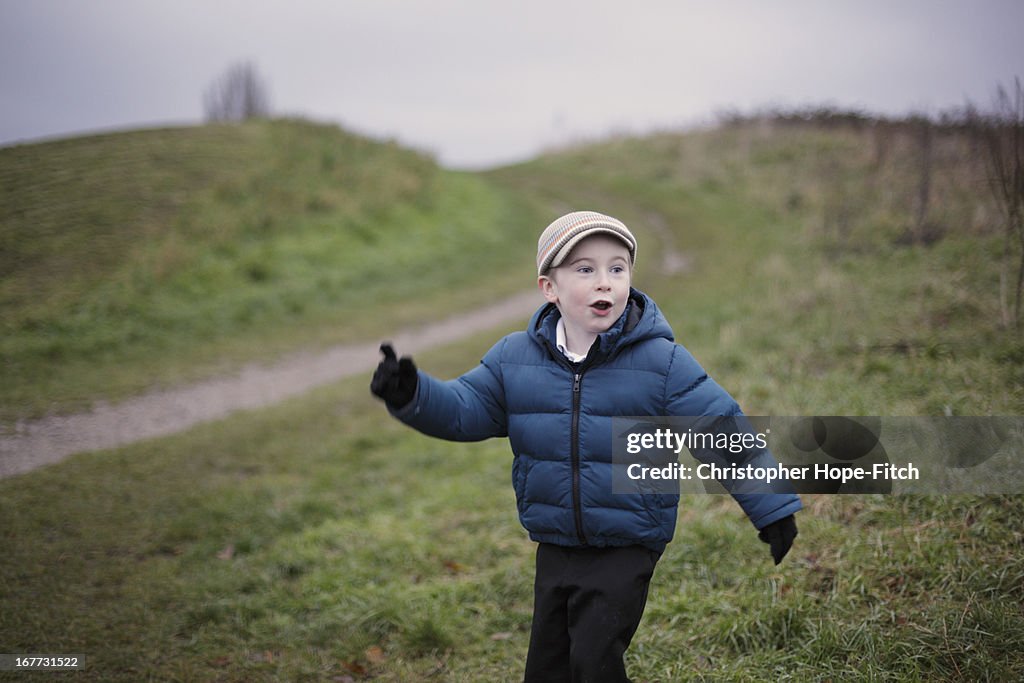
[0, 0, 1024, 168]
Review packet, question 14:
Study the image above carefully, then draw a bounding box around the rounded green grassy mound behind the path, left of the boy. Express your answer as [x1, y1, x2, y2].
[0, 121, 537, 421]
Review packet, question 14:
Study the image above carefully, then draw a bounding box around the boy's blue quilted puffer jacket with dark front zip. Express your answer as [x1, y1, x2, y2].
[392, 289, 801, 551]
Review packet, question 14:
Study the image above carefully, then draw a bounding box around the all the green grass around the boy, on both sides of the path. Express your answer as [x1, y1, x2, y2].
[0, 116, 1024, 682]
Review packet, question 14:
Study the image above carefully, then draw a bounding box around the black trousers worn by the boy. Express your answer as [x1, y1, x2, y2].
[525, 543, 660, 683]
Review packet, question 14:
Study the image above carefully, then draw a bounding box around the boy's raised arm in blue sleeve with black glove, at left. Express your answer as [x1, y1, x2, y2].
[371, 340, 508, 441]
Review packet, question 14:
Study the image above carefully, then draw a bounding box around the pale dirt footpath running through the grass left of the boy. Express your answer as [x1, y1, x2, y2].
[0, 290, 543, 478]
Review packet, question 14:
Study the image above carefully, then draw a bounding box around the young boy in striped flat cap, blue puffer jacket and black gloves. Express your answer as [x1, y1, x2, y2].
[371, 211, 801, 682]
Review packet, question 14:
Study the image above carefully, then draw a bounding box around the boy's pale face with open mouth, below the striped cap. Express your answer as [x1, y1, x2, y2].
[538, 234, 632, 335]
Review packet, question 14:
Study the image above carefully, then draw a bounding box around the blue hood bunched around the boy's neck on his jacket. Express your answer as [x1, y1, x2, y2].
[526, 287, 675, 360]
